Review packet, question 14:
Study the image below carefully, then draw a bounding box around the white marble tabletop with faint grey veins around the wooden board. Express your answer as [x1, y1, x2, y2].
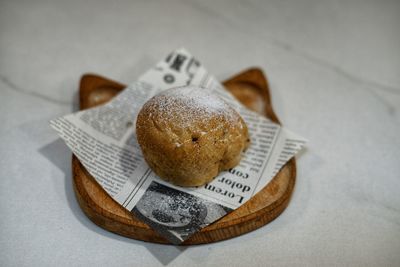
[0, 0, 400, 266]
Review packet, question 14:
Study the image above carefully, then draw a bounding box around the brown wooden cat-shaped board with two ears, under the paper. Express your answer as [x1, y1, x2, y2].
[72, 68, 296, 245]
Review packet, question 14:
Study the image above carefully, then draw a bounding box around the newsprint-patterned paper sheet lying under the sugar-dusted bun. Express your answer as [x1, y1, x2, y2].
[50, 49, 305, 244]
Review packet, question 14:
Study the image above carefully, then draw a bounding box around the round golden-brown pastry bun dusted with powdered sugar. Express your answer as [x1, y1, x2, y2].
[136, 86, 250, 186]
